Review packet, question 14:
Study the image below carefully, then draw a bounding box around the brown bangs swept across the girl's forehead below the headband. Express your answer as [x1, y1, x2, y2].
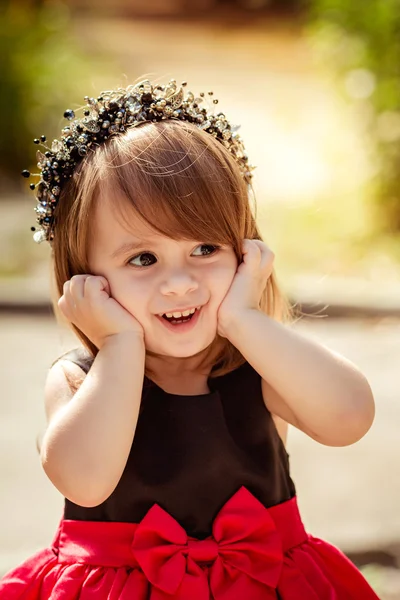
[98, 121, 248, 254]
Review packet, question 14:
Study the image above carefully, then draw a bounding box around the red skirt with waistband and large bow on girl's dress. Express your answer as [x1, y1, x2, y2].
[0, 487, 379, 600]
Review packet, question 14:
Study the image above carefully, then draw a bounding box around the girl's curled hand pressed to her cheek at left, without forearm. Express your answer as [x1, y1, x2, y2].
[58, 275, 144, 349]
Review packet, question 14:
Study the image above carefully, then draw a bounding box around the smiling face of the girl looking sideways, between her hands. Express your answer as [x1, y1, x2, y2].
[89, 197, 237, 358]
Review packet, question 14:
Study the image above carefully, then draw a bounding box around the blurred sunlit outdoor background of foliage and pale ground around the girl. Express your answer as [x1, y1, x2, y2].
[0, 0, 400, 600]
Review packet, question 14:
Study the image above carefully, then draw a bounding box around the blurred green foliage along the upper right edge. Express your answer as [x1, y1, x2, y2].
[308, 0, 400, 232]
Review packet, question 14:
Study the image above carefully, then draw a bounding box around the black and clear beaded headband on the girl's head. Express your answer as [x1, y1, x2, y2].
[22, 79, 253, 243]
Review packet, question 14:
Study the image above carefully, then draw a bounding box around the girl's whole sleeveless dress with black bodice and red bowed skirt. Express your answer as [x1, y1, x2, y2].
[0, 351, 378, 600]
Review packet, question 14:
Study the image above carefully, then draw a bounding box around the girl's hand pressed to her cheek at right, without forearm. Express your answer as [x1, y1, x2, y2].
[218, 239, 274, 337]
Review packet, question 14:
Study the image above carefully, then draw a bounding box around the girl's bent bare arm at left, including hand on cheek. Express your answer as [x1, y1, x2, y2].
[41, 275, 145, 506]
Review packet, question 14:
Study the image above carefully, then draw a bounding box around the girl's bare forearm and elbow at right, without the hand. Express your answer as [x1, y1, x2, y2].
[226, 309, 375, 446]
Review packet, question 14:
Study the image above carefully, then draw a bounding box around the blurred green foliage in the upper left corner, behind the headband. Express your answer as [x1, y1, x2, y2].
[0, 0, 115, 192]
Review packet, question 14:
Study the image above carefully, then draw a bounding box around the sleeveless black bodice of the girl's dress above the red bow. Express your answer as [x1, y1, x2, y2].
[63, 350, 295, 538]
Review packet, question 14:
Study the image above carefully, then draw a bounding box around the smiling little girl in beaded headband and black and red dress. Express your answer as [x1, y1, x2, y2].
[0, 81, 377, 600]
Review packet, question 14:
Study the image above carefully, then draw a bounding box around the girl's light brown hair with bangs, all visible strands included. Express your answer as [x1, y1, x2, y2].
[52, 120, 290, 376]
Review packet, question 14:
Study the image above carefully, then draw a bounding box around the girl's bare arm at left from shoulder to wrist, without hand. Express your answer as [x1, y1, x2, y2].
[41, 332, 145, 506]
